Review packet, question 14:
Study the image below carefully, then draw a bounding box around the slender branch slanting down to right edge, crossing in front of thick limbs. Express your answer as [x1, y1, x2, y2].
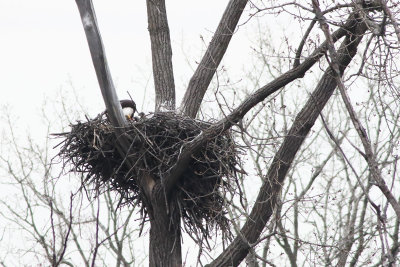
[312, 0, 400, 218]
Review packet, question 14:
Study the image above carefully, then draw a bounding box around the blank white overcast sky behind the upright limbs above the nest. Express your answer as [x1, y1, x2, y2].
[0, 0, 260, 134]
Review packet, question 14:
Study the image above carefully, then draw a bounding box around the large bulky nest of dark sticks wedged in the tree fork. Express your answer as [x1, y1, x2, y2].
[54, 112, 239, 242]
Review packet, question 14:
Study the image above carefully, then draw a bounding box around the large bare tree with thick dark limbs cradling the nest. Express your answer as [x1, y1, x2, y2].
[72, 0, 400, 266]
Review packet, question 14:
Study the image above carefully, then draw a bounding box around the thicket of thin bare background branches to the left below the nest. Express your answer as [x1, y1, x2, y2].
[0, 103, 144, 266]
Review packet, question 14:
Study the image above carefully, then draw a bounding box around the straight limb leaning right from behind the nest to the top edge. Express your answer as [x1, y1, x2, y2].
[180, 0, 248, 118]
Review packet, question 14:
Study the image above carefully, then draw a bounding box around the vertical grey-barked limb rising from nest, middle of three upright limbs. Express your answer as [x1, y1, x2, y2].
[146, 0, 175, 111]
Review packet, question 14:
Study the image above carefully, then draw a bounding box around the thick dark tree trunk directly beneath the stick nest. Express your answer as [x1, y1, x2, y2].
[149, 196, 182, 267]
